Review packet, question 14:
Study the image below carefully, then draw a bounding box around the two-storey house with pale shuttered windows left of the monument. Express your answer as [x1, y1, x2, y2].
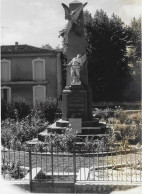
[1, 42, 62, 103]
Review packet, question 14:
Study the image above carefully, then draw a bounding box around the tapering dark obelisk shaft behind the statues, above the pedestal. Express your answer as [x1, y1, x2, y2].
[66, 1, 88, 86]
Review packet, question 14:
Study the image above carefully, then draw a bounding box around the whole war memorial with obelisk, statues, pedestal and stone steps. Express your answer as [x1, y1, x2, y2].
[38, 1, 106, 141]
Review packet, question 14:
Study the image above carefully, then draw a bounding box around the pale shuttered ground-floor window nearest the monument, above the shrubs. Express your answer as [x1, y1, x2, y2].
[33, 86, 46, 103]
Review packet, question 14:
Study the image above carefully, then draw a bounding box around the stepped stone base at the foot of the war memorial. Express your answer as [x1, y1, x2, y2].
[38, 118, 108, 141]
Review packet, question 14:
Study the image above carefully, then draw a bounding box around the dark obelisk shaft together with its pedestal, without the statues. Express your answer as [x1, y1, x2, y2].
[62, 1, 92, 120]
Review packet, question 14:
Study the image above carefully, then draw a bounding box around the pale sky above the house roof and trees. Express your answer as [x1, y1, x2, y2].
[0, 0, 142, 48]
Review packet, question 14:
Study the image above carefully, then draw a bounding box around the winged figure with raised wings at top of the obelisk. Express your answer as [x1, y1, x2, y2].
[60, 3, 87, 38]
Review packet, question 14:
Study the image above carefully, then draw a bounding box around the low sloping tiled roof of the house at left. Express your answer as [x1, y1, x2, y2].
[1, 44, 58, 54]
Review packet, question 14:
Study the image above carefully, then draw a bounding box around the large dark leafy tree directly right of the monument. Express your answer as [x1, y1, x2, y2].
[84, 10, 131, 101]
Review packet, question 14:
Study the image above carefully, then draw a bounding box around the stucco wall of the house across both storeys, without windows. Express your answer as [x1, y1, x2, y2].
[2, 54, 57, 103]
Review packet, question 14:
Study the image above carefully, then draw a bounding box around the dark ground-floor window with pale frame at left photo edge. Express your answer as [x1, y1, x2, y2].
[1, 86, 11, 102]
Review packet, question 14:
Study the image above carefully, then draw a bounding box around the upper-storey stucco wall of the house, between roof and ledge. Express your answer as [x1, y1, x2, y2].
[2, 55, 57, 81]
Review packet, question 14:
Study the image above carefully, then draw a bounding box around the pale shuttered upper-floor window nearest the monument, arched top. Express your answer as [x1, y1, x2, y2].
[32, 58, 45, 81]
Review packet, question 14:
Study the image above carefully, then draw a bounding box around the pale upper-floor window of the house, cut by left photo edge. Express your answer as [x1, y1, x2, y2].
[1, 59, 11, 82]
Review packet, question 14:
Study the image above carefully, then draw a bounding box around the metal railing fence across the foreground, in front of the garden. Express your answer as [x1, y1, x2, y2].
[1, 145, 142, 182]
